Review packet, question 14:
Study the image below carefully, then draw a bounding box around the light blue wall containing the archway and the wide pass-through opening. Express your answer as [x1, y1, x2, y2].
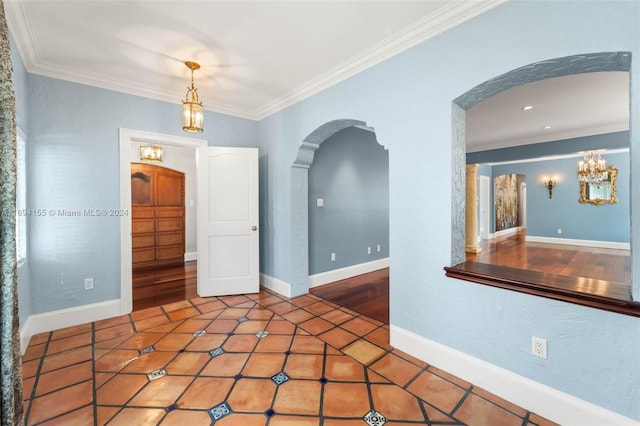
[258, 0, 640, 420]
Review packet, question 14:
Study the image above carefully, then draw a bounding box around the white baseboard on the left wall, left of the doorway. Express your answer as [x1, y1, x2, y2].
[20, 299, 121, 354]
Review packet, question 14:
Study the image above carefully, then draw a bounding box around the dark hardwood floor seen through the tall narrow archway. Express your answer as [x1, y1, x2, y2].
[309, 268, 389, 324]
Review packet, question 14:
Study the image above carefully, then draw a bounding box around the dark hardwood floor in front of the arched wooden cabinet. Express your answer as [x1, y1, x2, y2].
[133, 261, 197, 311]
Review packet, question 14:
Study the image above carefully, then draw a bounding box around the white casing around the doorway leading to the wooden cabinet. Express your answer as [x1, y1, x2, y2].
[119, 128, 208, 315]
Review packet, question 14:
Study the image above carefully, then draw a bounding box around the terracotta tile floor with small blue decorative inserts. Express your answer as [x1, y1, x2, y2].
[23, 290, 553, 426]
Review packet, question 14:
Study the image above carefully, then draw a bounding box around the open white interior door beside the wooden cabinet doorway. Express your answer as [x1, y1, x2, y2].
[197, 147, 259, 297]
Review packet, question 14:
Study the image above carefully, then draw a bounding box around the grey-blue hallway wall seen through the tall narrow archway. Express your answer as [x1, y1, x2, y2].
[309, 127, 389, 275]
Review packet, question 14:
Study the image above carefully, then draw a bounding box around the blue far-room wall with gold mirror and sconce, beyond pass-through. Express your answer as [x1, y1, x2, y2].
[467, 131, 631, 243]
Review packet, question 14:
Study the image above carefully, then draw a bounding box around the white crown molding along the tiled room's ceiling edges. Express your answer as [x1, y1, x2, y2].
[5, 0, 507, 121]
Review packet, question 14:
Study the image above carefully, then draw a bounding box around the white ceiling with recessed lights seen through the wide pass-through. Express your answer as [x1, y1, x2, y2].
[466, 72, 629, 152]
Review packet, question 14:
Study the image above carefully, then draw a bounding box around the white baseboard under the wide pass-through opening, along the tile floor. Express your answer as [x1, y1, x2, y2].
[390, 325, 640, 426]
